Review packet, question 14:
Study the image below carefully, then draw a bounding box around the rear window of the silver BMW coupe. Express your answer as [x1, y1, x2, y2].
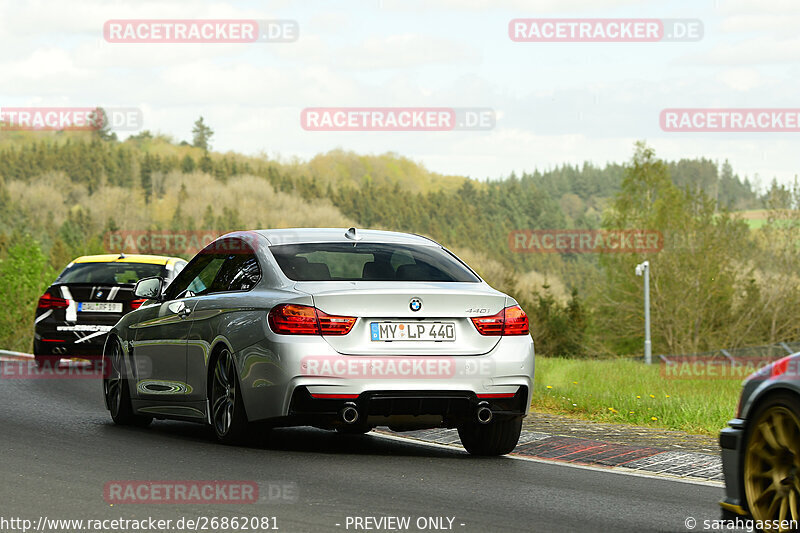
[270, 242, 480, 283]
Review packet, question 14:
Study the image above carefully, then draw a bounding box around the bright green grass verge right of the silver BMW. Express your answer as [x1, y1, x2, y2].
[532, 356, 741, 435]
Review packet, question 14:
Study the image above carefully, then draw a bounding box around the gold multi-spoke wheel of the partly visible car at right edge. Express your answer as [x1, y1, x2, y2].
[744, 405, 800, 531]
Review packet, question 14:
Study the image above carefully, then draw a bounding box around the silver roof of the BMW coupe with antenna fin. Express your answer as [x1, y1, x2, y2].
[250, 228, 439, 246]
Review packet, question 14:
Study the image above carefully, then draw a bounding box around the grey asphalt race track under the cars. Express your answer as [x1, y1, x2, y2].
[0, 363, 723, 533]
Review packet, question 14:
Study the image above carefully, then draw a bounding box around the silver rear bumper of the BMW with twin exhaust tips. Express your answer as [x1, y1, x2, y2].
[235, 335, 534, 427]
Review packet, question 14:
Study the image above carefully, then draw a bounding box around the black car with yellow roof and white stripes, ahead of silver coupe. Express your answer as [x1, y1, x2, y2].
[33, 254, 186, 364]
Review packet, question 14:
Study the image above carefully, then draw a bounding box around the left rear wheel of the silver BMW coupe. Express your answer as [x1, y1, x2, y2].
[211, 348, 249, 444]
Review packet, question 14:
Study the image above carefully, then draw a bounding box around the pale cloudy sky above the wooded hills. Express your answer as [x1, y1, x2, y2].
[0, 0, 800, 186]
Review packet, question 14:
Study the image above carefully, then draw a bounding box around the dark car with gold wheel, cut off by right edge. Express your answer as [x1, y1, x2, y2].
[720, 353, 800, 531]
